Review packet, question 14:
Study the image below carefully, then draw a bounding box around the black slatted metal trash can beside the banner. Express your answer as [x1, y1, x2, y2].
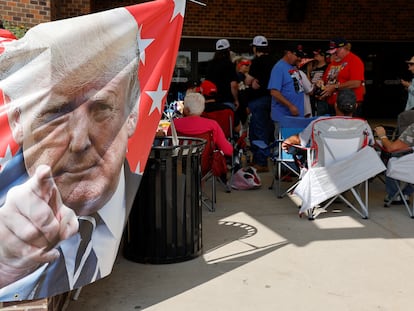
[123, 136, 206, 264]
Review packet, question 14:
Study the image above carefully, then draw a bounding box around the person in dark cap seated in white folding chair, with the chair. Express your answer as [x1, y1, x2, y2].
[282, 89, 385, 219]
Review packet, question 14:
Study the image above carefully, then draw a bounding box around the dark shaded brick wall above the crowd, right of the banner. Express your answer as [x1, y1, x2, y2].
[183, 0, 414, 40]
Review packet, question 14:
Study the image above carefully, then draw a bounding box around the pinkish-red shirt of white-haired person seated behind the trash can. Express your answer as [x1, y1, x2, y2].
[168, 116, 233, 156]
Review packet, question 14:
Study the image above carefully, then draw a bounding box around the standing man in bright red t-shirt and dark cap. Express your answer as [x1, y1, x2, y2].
[321, 38, 365, 116]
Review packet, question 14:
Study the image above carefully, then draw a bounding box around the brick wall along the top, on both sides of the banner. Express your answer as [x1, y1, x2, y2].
[0, 0, 414, 41]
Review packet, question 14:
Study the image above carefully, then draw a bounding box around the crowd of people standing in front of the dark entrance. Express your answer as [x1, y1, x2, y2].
[163, 35, 414, 207]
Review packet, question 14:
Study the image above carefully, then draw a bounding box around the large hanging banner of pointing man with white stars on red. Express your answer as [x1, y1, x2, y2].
[0, 0, 185, 301]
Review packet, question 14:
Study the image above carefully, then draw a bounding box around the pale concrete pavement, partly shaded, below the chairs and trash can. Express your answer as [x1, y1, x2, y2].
[64, 173, 414, 311]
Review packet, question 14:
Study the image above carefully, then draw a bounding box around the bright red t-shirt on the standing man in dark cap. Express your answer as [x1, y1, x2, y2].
[323, 52, 365, 105]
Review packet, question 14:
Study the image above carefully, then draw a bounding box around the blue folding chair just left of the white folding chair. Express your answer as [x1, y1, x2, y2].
[266, 116, 317, 198]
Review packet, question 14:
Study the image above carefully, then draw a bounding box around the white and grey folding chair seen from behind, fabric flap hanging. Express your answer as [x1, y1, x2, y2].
[294, 117, 386, 219]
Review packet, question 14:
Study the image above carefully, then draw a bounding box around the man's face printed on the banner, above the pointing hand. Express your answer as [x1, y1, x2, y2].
[10, 65, 136, 215]
